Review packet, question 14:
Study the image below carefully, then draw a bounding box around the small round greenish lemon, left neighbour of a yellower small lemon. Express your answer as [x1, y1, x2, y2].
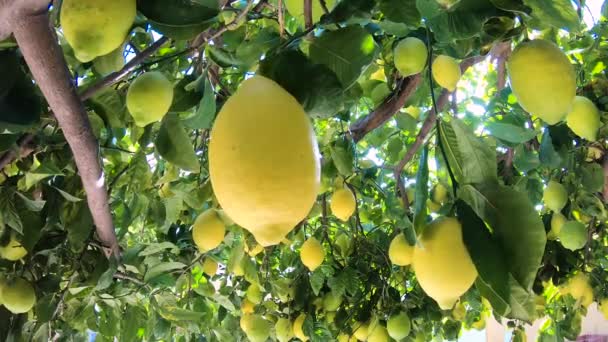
[393, 37, 428, 76]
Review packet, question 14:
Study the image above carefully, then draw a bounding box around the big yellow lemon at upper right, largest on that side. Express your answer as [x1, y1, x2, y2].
[507, 39, 576, 125]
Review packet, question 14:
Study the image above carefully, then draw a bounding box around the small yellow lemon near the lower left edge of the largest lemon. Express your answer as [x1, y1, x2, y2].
[192, 209, 226, 252]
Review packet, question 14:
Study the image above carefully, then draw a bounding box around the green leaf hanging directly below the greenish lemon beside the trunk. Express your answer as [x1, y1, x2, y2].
[154, 113, 200, 172]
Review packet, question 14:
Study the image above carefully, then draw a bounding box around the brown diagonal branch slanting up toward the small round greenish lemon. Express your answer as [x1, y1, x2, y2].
[350, 74, 422, 143]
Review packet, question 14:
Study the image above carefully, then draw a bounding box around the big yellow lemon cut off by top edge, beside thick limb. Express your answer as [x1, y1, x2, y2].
[60, 0, 136, 62]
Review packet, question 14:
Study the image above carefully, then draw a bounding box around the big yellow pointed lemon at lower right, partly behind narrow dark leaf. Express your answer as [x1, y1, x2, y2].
[412, 217, 477, 310]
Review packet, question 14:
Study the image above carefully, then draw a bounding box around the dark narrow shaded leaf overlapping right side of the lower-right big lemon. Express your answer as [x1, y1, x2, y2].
[456, 200, 509, 315]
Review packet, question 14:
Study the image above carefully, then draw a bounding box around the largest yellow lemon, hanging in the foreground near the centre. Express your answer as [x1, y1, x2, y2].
[209, 76, 321, 246]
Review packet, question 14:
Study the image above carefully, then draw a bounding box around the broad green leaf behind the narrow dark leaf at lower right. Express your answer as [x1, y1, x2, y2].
[458, 183, 547, 290]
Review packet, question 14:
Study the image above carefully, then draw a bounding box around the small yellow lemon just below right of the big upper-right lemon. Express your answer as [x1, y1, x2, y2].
[566, 96, 600, 141]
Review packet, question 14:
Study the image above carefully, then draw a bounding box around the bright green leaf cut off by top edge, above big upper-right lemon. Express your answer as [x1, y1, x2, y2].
[523, 0, 580, 31]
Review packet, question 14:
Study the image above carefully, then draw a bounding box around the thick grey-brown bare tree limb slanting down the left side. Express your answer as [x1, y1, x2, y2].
[10, 8, 120, 258]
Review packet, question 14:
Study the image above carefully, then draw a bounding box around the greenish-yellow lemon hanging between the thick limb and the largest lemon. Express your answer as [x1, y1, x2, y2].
[127, 71, 173, 127]
